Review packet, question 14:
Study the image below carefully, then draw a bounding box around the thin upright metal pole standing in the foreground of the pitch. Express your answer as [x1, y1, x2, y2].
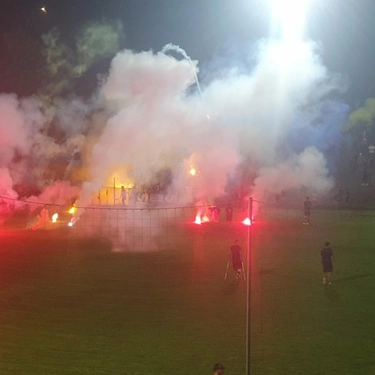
[246, 197, 253, 375]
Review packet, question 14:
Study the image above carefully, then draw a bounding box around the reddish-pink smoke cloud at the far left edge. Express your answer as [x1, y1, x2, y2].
[0, 94, 84, 211]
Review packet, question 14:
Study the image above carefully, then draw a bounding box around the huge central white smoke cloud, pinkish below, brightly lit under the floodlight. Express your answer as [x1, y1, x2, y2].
[72, 41, 335, 210]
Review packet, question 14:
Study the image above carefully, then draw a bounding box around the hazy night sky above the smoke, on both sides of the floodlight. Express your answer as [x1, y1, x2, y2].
[0, 0, 375, 105]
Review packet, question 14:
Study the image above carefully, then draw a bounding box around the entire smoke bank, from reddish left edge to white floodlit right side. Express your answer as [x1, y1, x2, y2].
[0, 30, 346, 229]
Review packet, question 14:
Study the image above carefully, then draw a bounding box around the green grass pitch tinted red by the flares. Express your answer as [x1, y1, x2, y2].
[0, 211, 375, 375]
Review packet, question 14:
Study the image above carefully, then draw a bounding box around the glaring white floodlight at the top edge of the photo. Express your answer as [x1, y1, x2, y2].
[269, 0, 312, 39]
